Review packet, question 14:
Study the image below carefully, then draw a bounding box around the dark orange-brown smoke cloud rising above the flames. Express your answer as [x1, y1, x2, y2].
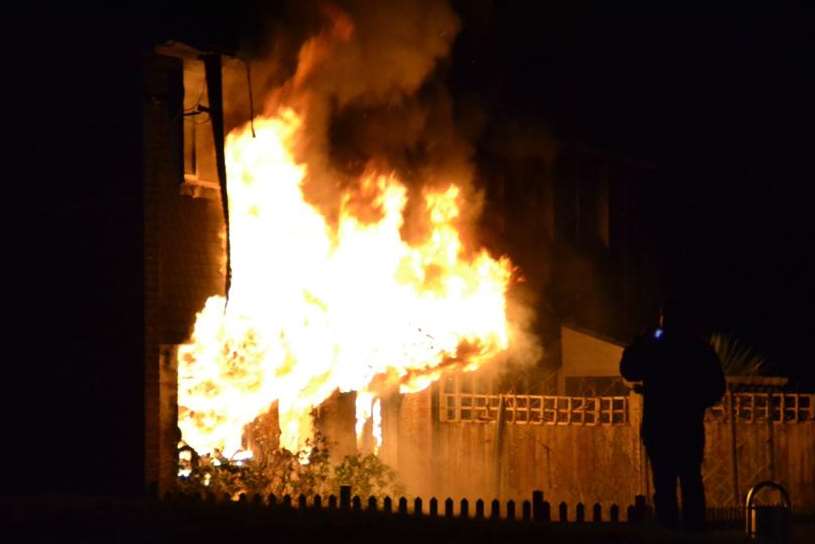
[287, 1, 471, 234]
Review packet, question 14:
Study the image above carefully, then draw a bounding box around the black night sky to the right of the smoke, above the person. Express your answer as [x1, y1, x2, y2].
[446, 2, 815, 380]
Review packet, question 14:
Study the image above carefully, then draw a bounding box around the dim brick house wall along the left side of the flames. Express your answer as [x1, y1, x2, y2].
[144, 55, 224, 496]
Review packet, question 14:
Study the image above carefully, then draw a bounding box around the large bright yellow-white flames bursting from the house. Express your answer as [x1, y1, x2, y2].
[178, 109, 511, 455]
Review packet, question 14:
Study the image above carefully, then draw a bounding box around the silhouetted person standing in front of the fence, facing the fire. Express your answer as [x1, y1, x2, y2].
[620, 300, 725, 531]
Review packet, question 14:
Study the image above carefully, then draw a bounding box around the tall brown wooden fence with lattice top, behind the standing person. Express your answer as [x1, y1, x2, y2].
[420, 387, 815, 511]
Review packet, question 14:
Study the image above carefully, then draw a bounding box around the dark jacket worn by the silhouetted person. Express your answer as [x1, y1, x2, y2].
[620, 331, 725, 446]
